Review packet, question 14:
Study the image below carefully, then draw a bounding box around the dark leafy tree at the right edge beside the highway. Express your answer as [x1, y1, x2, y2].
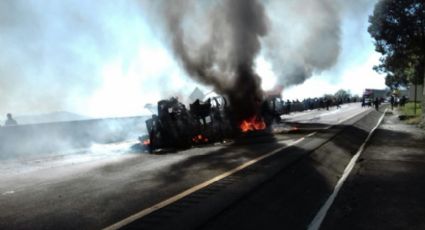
[368, 0, 425, 117]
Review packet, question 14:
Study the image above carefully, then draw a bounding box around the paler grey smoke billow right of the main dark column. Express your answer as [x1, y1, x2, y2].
[264, 0, 341, 87]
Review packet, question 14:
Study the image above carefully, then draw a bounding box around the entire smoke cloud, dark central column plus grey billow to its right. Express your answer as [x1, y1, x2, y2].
[142, 0, 373, 118]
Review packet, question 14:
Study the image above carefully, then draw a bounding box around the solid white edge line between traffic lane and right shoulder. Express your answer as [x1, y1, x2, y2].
[308, 109, 388, 230]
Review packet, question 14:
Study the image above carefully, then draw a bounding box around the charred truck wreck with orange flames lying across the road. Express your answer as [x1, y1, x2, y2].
[139, 96, 284, 152]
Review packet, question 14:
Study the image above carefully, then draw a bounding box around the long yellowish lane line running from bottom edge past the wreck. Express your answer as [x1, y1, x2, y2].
[104, 107, 364, 230]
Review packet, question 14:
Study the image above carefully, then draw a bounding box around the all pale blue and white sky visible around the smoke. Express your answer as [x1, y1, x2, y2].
[0, 0, 385, 117]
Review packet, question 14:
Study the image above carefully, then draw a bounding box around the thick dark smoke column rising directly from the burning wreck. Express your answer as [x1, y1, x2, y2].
[144, 0, 268, 120]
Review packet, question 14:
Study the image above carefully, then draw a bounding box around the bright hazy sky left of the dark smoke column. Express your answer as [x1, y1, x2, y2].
[0, 0, 195, 118]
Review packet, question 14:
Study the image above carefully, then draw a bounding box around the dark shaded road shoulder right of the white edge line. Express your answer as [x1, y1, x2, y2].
[321, 109, 425, 229]
